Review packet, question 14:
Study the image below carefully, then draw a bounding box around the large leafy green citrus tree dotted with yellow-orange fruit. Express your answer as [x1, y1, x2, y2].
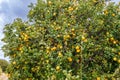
[3, 0, 120, 80]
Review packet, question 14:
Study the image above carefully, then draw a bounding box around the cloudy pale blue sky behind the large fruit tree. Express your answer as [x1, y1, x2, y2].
[0, 0, 120, 60]
